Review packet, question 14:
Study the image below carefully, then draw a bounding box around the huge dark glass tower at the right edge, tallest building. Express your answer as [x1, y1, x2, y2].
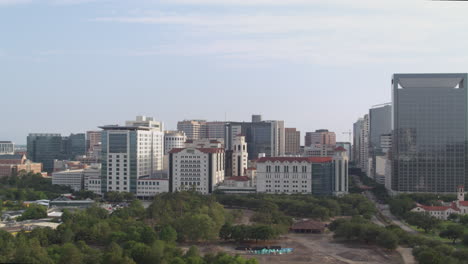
[392, 73, 468, 193]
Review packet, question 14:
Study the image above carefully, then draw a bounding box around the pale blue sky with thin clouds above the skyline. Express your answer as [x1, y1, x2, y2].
[0, 0, 468, 144]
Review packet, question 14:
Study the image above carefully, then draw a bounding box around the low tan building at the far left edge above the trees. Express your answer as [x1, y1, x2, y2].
[0, 154, 42, 177]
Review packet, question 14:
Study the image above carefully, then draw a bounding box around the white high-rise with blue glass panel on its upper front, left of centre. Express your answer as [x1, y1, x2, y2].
[100, 126, 164, 194]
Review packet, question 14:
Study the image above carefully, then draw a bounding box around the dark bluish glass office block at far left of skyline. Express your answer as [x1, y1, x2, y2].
[27, 133, 63, 173]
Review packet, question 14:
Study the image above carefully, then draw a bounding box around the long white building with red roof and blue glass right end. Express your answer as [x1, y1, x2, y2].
[257, 157, 347, 195]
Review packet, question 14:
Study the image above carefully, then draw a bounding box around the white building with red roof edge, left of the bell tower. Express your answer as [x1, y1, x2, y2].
[169, 148, 225, 194]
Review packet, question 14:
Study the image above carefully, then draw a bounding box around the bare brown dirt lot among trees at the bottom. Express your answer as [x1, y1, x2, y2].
[188, 234, 403, 264]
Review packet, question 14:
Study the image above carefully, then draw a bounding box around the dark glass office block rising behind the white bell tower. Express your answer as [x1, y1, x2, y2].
[224, 114, 285, 159]
